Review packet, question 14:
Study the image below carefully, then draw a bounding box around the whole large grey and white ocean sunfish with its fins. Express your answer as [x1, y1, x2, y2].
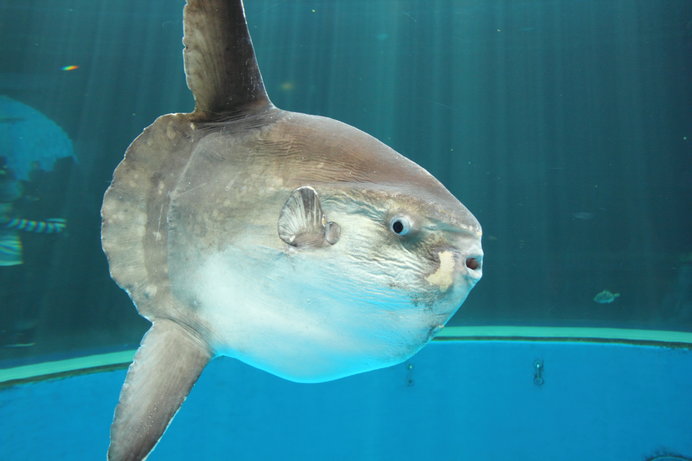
[101, 0, 483, 460]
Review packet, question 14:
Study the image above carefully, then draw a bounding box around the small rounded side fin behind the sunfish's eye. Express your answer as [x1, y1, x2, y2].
[278, 187, 341, 247]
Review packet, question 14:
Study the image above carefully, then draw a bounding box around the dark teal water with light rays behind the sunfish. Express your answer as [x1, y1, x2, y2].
[0, 0, 692, 359]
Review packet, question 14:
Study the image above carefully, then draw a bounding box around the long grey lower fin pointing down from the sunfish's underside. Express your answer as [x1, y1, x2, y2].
[108, 320, 211, 461]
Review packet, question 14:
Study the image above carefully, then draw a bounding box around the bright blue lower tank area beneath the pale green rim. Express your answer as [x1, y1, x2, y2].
[0, 341, 692, 461]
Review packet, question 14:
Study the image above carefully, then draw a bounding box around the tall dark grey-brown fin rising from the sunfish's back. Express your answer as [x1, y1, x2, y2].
[183, 0, 271, 117]
